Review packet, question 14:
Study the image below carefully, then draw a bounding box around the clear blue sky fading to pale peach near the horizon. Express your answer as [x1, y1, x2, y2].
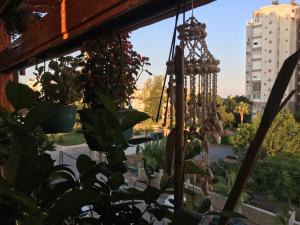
[23, 0, 300, 97]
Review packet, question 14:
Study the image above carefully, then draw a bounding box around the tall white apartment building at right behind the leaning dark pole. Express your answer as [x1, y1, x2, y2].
[246, 1, 300, 114]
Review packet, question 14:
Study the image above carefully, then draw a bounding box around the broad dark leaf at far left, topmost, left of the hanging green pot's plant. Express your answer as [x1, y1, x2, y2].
[5, 81, 38, 110]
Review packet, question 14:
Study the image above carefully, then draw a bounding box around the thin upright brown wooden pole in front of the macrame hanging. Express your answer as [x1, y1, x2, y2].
[174, 46, 184, 213]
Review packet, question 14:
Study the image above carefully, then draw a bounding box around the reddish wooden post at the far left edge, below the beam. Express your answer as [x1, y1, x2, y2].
[0, 25, 15, 111]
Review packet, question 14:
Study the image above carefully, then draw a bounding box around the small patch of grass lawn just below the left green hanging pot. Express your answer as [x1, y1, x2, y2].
[49, 132, 85, 146]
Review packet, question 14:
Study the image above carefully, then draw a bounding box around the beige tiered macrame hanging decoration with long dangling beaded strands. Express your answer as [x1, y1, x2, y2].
[165, 16, 223, 195]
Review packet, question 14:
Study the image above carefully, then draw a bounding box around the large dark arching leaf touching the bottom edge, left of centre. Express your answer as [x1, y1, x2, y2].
[47, 189, 101, 225]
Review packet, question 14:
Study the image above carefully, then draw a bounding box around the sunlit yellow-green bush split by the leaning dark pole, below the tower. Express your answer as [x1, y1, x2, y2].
[233, 111, 300, 155]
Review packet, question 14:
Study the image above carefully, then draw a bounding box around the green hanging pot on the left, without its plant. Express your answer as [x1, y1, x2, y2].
[42, 104, 77, 134]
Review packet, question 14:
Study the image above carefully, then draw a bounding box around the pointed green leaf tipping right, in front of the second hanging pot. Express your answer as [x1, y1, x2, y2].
[120, 110, 150, 131]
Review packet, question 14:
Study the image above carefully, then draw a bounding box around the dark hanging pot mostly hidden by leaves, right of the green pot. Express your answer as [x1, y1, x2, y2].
[78, 110, 133, 151]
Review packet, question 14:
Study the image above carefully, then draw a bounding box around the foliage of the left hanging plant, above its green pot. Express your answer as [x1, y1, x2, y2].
[34, 56, 82, 105]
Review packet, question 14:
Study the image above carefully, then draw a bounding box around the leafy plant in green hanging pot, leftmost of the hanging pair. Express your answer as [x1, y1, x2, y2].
[34, 56, 82, 133]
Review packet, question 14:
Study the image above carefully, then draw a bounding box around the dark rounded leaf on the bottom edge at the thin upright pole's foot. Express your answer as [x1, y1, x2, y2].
[172, 209, 202, 225]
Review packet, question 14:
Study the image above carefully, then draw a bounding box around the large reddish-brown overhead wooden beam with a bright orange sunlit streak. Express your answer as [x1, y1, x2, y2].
[0, 0, 214, 72]
